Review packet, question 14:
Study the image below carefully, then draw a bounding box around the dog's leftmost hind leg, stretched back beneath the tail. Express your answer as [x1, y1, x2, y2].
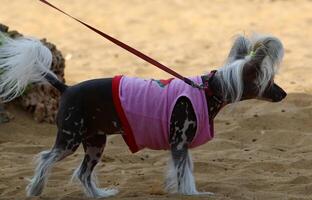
[26, 109, 84, 196]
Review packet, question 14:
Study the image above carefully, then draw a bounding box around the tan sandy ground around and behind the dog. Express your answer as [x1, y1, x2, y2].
[0, 0, 312, 200]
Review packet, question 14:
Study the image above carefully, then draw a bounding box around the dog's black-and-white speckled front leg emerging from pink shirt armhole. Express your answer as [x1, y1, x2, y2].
[165, 97, 212, 195]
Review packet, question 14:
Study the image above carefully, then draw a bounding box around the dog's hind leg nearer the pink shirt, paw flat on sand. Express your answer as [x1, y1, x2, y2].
[73, 131, 118, 198]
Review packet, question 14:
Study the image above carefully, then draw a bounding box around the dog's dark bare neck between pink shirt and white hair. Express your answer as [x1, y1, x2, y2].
[202, 72, 228, 121]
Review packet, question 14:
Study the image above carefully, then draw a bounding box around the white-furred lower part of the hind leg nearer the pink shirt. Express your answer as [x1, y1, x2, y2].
[72, 164, 118, 198]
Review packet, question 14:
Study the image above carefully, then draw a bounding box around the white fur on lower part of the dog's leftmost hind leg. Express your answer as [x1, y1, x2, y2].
[26, 151, 59, 196]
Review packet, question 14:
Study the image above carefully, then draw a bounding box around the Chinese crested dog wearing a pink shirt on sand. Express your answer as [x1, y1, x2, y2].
[0, 35, 287, 198]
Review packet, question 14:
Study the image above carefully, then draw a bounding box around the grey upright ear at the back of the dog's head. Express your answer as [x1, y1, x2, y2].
[226, 35, 251, 63]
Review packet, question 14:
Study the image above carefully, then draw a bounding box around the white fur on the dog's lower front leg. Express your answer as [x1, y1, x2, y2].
[165, 153, 213, 195]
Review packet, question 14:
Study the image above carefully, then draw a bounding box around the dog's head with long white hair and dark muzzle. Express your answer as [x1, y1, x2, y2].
[219, 33, 287, 102]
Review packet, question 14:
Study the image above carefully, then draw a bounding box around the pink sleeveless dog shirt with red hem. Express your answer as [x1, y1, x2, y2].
[112, 76, 214, 153]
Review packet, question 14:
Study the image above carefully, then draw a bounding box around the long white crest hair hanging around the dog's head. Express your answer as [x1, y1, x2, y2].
[216, 34, 284, 102]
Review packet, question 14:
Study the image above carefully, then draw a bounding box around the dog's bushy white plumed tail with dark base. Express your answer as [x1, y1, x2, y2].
[0, 33, 67, 102]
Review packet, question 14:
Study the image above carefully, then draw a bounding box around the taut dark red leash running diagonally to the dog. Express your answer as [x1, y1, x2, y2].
[39, 0, 203, 89]
